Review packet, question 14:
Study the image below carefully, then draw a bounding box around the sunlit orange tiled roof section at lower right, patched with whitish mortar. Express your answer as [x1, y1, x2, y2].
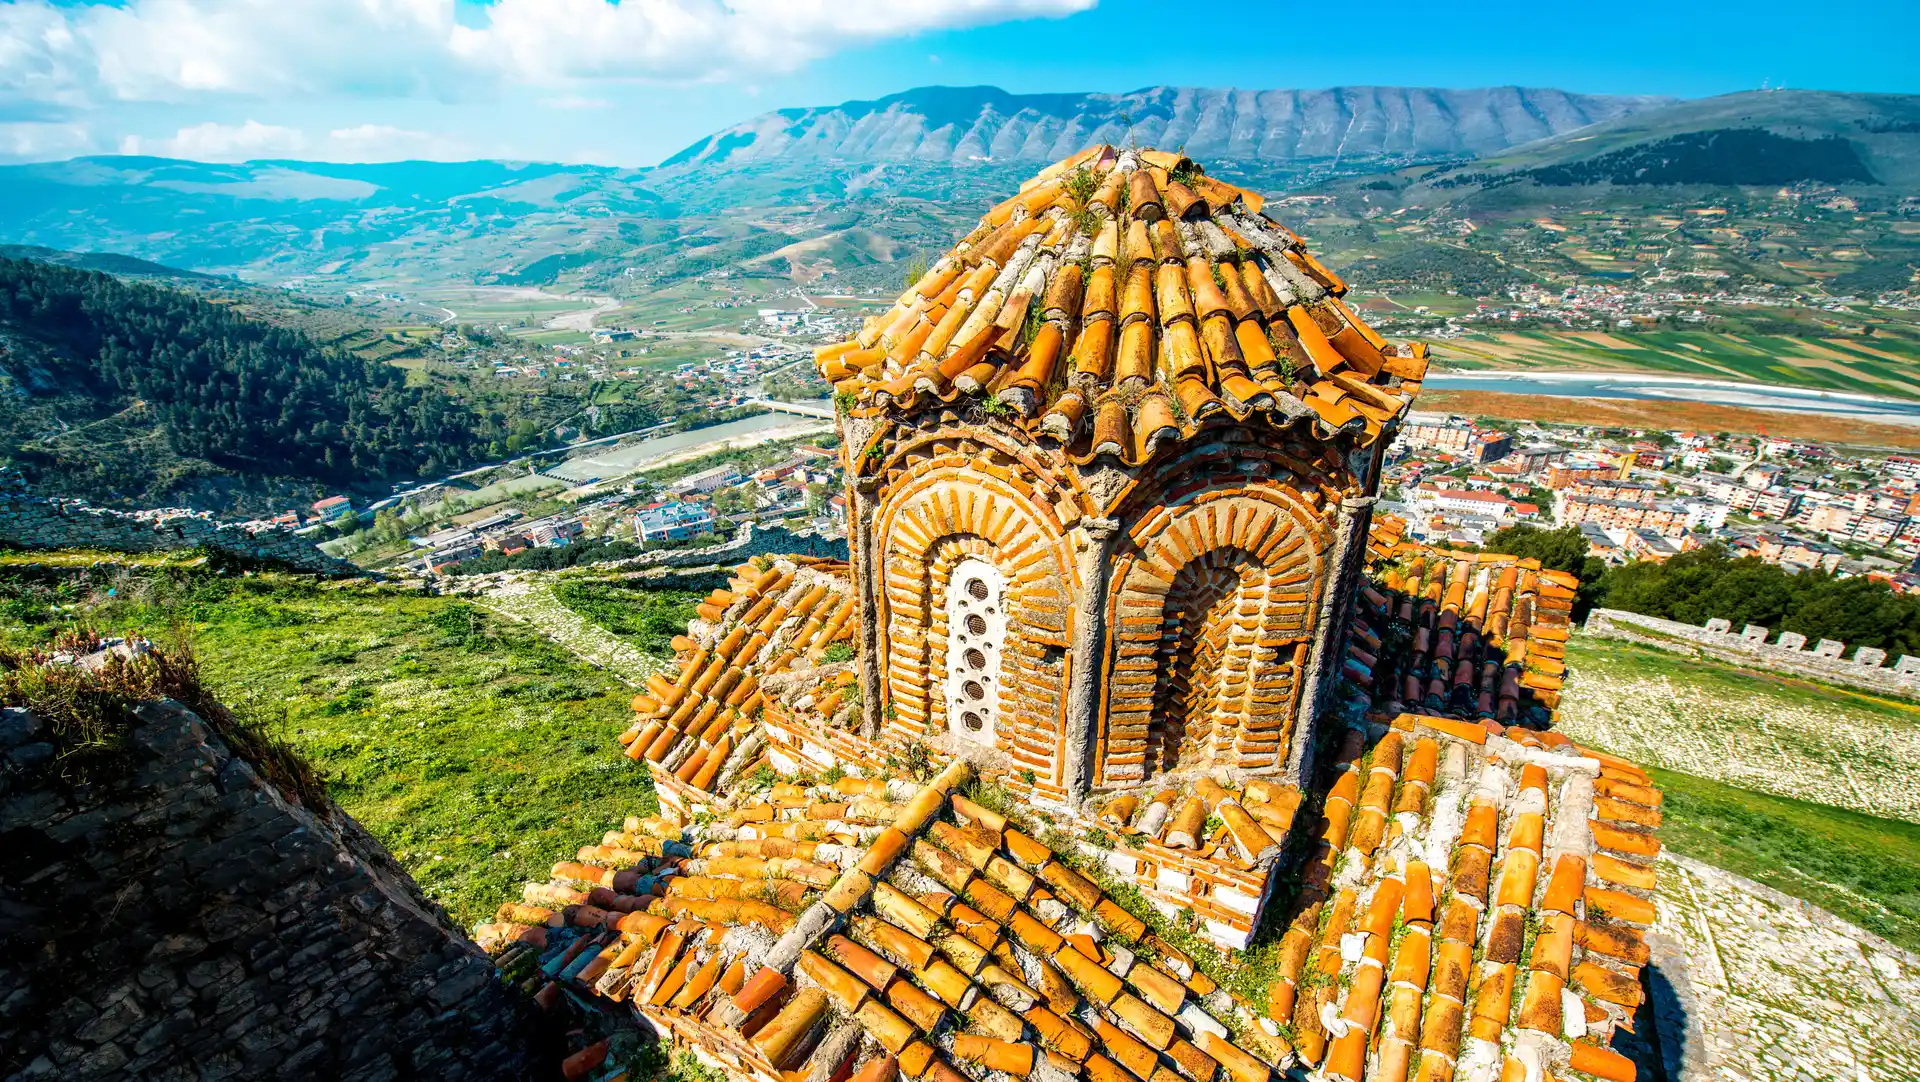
[1267, 716, 1661, 1082]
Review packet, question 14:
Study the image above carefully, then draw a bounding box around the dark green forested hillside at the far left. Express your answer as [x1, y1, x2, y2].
[0, 259, 486, 491]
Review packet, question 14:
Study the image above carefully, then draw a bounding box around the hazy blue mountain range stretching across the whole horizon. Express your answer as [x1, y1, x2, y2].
[0, 86, 1920, 290]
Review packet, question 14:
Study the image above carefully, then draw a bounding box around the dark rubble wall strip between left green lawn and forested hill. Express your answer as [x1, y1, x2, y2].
[0, 489, 367, 576]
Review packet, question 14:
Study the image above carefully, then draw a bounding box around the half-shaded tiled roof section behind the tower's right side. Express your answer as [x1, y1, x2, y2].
[1342, 516, 1578, 723]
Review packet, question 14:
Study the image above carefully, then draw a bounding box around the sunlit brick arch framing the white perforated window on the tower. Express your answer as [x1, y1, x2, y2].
[874, 439, 1079, 788]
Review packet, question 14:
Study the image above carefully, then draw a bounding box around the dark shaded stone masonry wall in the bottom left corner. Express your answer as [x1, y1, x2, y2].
[0, 702, 559, 1082]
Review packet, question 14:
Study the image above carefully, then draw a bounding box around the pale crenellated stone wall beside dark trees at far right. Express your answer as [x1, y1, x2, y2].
[1582, 608, 1920, 698]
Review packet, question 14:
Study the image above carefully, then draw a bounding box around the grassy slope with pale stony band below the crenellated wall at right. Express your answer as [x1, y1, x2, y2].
[1557, 637, 1920, 950]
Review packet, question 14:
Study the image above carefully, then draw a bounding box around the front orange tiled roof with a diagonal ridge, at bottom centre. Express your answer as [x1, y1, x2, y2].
[478, 764, 1284, 1082]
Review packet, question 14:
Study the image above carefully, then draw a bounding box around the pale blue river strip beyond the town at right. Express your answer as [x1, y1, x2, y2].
[1423, 372, 1920, 426]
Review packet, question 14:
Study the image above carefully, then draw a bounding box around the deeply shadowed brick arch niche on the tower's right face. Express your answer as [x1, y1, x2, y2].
[1094, 439, 1336, 785]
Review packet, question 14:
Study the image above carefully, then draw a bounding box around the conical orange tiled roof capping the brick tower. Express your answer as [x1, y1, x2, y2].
[818, 146, 1427, 464]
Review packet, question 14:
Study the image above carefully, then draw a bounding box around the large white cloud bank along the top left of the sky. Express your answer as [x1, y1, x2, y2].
[0, 0, 1096, 107]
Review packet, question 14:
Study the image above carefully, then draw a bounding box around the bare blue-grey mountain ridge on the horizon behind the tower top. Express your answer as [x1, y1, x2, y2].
[660, 86, 1676, 169]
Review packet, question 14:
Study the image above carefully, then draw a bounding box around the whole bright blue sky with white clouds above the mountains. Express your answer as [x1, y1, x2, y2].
[0, 0, 1920, 165]
